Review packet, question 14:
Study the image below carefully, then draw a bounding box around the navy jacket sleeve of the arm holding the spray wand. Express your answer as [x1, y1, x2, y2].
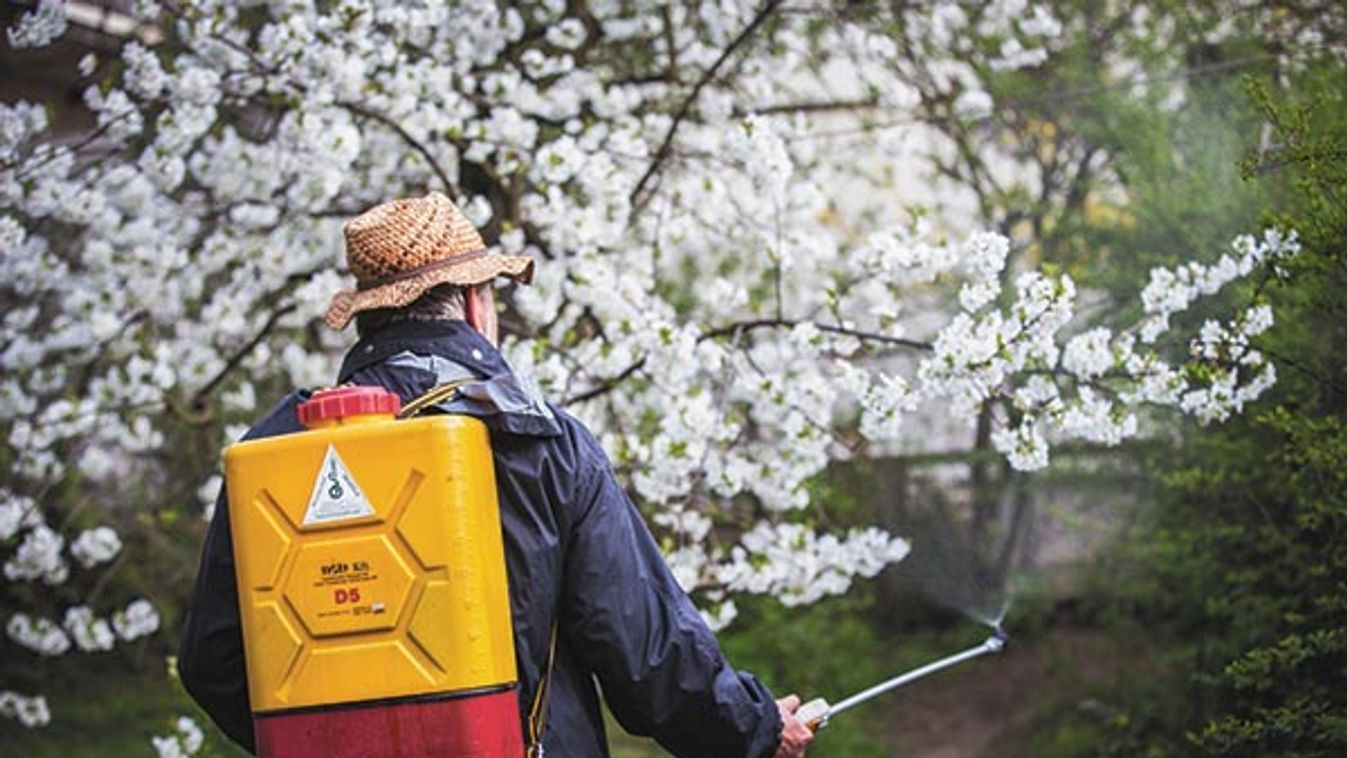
[562, 439, 781, 758]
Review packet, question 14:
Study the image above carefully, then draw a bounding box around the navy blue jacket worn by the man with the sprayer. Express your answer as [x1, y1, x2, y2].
[178, 322, 781, 758]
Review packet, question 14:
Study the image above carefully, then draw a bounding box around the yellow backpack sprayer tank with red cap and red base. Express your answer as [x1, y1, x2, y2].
[225, 386, 524, 758]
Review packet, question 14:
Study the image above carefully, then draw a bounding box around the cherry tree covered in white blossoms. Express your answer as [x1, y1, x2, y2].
[0, 0, 1297, 737]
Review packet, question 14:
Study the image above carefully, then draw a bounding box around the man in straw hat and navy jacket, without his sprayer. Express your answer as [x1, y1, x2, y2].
[178, 193, 812, 758]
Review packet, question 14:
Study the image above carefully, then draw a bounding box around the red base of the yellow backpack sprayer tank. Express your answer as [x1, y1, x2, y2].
[253, 688, 524, 758]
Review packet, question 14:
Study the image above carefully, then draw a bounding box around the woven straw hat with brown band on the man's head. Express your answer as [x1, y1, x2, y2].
[327, 193, 533, 330]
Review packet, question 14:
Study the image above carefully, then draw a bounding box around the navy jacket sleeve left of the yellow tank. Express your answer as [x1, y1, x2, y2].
[178, 487, 255, 753]
